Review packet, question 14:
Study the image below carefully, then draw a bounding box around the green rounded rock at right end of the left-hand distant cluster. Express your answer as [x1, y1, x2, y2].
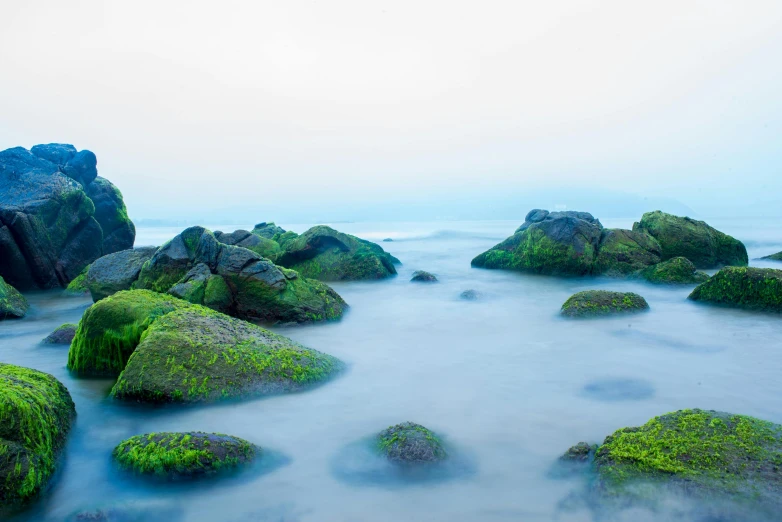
[274, 225, 398, 281]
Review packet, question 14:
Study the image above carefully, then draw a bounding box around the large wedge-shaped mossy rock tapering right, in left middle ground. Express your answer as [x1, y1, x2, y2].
[111, 305, 343, 403]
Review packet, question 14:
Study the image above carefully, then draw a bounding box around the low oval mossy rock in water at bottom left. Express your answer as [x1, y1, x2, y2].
[113, 432, 262, 478]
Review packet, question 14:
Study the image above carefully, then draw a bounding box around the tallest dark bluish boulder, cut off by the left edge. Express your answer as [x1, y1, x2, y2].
[0, 144, 135, 290]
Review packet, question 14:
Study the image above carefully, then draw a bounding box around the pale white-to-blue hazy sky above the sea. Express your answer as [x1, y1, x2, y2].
[0, 0, 782, 220]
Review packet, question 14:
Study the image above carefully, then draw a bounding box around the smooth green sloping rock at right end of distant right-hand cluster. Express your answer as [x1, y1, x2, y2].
[633, 210, 748, 268]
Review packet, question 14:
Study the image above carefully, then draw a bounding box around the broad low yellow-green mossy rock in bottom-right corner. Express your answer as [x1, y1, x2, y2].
[594, 409, 782, 504]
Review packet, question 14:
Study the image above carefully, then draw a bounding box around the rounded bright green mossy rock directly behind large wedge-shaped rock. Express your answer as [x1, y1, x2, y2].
[68, 290, 193, 377]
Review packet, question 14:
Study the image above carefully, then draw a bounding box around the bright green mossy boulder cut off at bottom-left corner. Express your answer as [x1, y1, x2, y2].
[0, 363, 76, 508]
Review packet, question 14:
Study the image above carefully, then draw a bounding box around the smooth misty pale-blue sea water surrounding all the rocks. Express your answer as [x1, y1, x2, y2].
[0, 219, 782, 522]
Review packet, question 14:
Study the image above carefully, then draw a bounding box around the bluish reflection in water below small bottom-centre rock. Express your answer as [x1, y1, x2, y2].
[330, 438, 476, 488]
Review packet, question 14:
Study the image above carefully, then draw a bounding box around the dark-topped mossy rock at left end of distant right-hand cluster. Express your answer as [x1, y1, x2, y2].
[472, 210, 603, 275]
